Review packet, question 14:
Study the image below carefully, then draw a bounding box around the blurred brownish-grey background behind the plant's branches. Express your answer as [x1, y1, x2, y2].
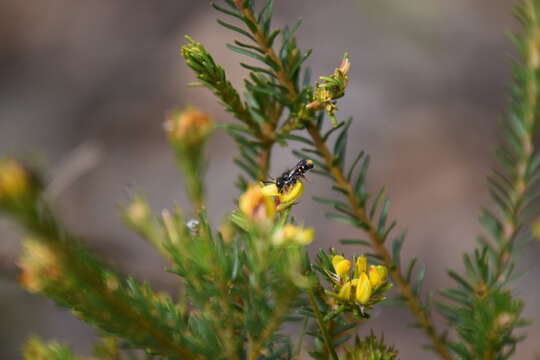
[0, 0, 540, 360]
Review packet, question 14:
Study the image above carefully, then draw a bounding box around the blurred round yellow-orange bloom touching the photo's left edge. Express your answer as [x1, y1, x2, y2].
[0, 159, 30, 200]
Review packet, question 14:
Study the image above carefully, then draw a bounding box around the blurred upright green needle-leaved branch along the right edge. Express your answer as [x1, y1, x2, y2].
[491, 0, 540, 280]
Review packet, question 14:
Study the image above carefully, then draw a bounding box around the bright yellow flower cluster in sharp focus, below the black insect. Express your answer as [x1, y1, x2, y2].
[332, 255, 388, 305]
